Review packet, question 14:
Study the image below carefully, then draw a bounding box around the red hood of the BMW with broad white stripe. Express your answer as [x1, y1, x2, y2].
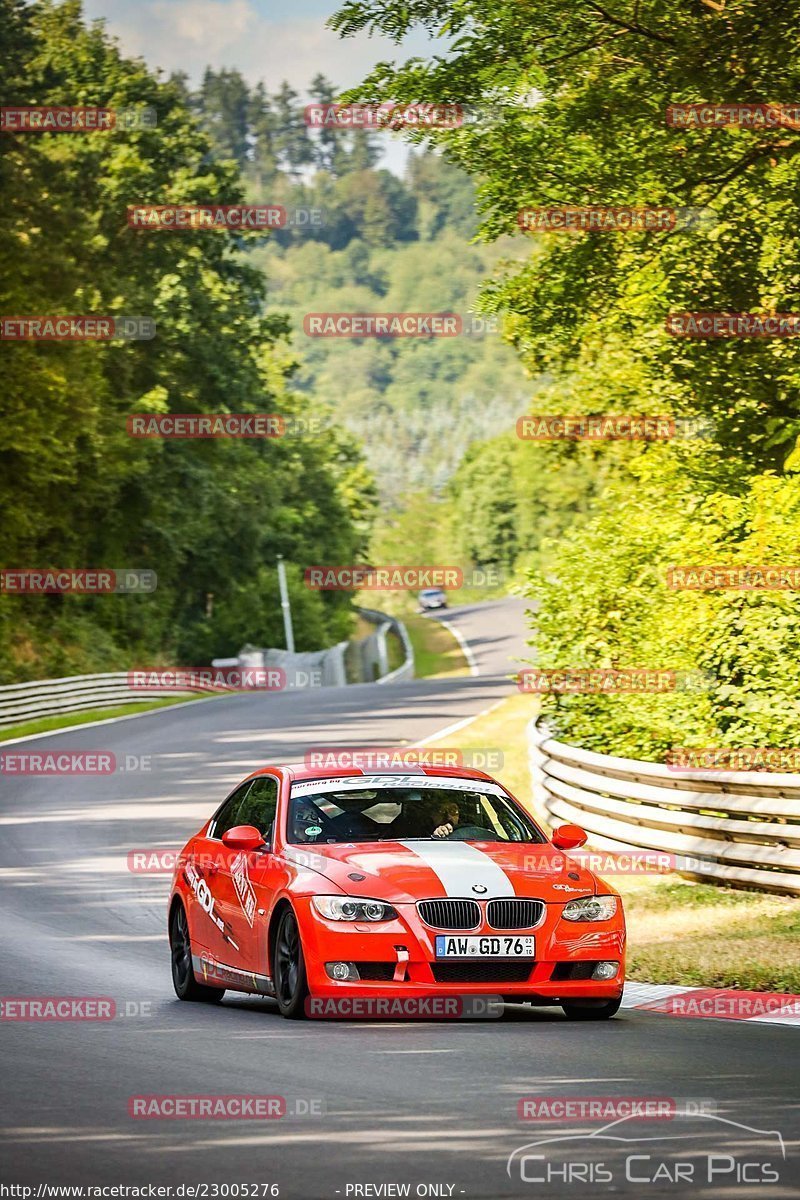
[281, 840, 596, 904]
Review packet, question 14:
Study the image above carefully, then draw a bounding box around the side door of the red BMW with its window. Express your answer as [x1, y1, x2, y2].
[213, 775, 278, 976]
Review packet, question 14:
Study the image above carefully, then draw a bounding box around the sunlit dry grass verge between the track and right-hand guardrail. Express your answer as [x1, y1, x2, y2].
[424, 696, 800, 994]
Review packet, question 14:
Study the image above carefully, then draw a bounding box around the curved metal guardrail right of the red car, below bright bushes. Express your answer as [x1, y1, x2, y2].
[528, 721, 800, 895]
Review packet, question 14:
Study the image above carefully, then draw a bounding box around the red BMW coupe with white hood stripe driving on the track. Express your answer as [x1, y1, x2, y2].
[169, 766, 625, 1020]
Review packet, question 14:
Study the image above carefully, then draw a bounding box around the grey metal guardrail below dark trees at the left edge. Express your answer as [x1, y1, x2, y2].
[0, 671, 203, 728]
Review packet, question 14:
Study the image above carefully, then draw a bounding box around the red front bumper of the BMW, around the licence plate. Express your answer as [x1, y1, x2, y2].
[295, 898, 625, 1004]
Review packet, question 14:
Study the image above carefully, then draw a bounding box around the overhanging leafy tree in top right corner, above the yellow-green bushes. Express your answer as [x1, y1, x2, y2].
[331, 0, 800, 468]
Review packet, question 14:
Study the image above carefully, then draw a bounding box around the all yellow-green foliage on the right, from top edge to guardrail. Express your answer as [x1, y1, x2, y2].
[331, 0, 800, 756]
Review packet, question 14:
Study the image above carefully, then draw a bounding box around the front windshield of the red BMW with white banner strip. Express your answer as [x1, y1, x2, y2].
[288, 780, 546, 845]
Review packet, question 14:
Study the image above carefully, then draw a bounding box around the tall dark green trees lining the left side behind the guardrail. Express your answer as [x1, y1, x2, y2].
[0, 0, 372, 680]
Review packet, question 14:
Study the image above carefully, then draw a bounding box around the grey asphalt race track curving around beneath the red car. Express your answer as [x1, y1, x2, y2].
[0, 600, 800, 1200]
